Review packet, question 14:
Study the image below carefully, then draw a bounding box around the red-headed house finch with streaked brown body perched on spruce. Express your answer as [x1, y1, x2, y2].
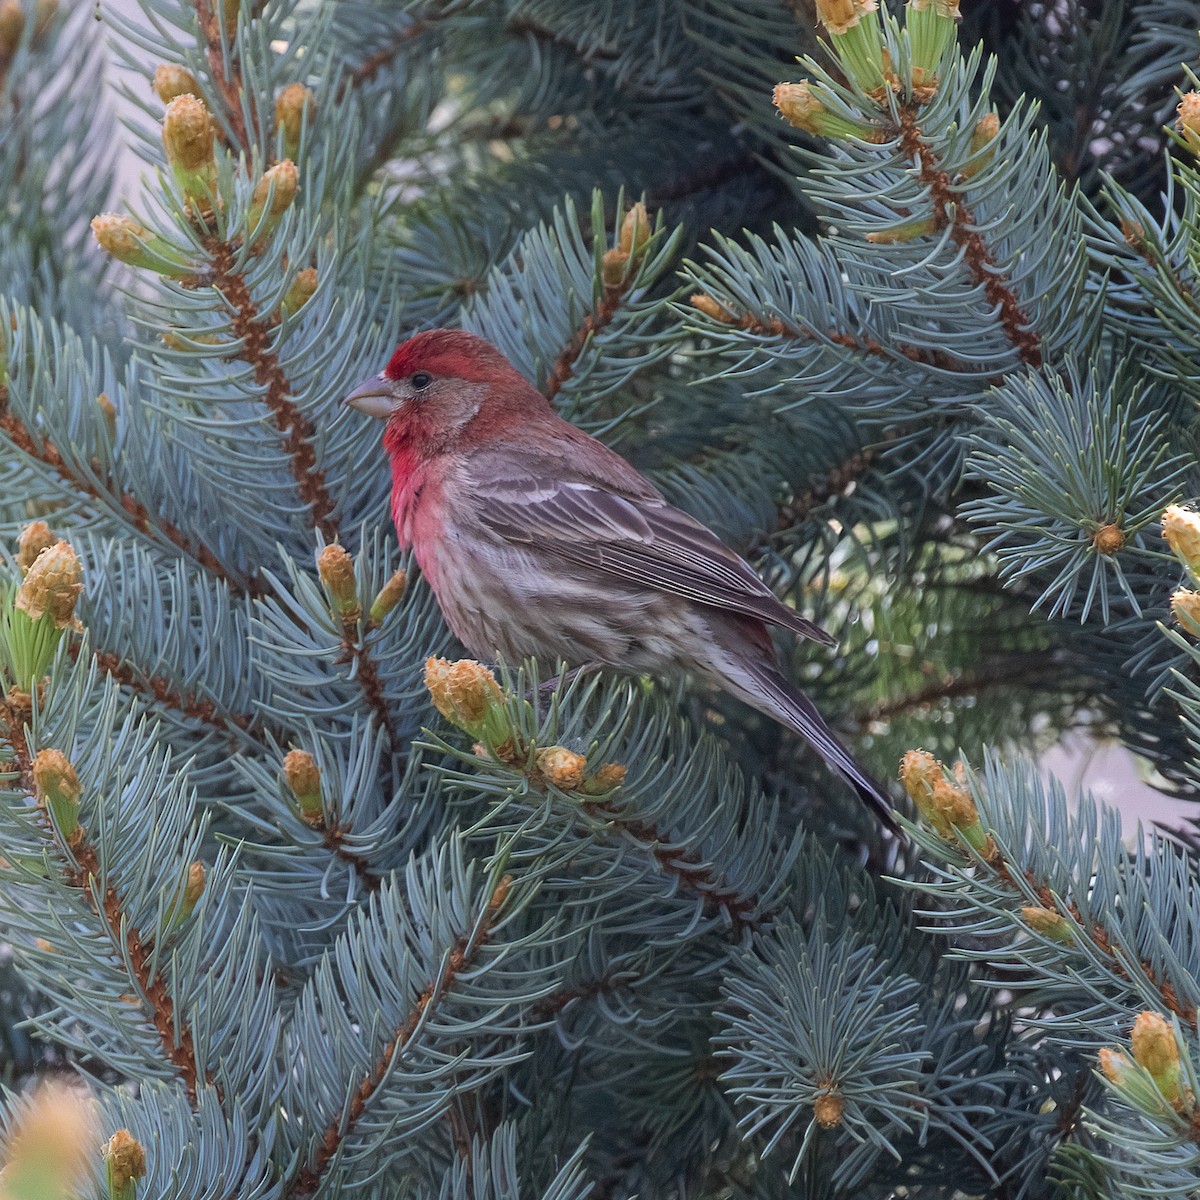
[346, 329, 892, 824]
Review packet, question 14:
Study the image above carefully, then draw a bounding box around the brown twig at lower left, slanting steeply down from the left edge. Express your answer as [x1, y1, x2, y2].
[0, 692, 216, 1105]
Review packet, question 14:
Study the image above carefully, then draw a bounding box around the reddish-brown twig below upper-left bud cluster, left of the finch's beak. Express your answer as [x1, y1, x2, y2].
[205, 239, 338, 541]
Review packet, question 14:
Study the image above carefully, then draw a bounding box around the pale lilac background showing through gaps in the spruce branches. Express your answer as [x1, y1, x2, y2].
[98, 0, 1200, 839]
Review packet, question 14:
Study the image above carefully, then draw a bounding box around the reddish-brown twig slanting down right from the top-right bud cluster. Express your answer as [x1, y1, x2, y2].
[898, 104, 1043, 368]
